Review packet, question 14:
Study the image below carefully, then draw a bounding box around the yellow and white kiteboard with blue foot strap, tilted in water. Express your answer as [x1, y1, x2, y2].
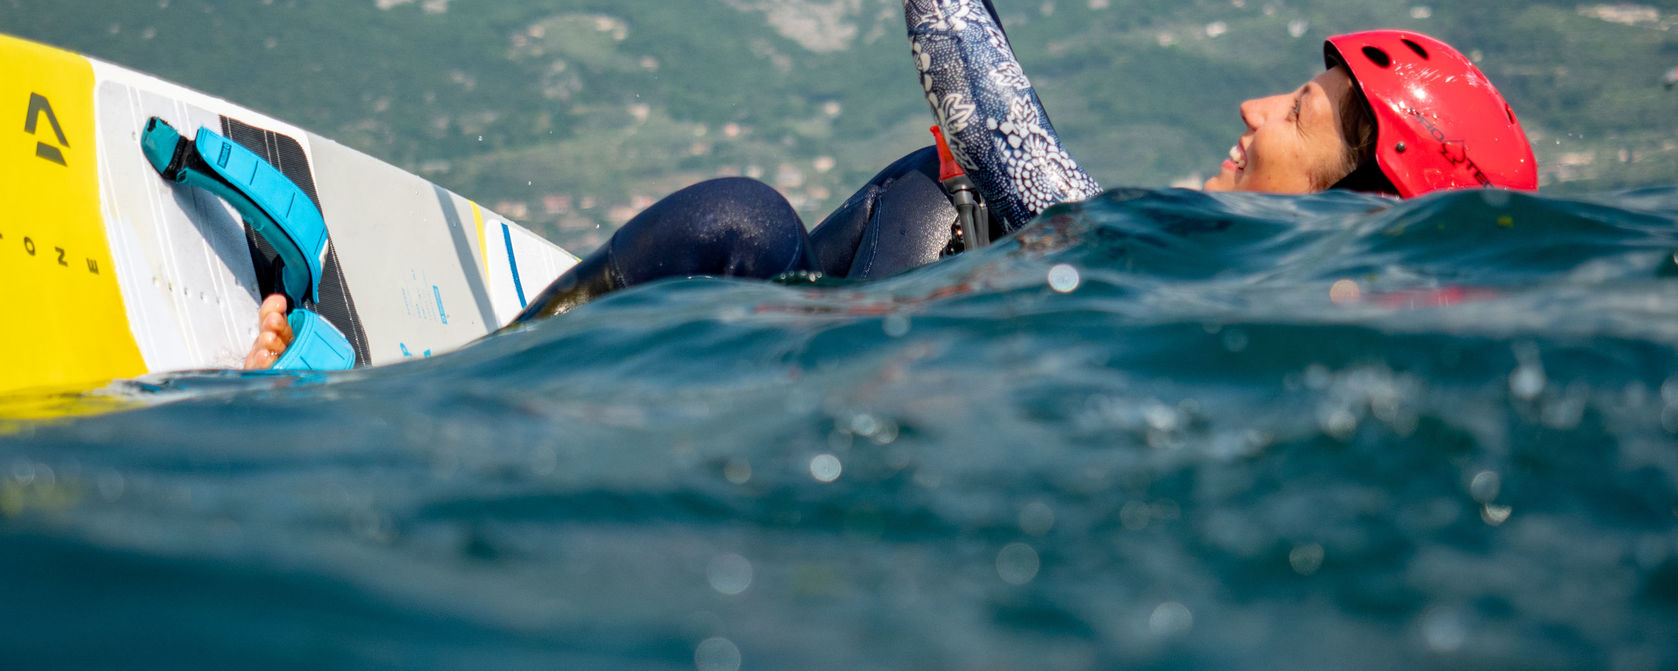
[0, 35, 576, 393]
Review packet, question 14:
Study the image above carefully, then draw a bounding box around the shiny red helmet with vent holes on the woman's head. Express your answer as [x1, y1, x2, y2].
[1322, 30, 1539, 198]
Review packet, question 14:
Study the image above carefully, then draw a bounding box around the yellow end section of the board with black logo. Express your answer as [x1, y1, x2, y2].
[0, 35, 146, 391]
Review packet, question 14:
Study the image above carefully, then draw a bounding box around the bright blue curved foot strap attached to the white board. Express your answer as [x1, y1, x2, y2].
[139, 117, 356, 371]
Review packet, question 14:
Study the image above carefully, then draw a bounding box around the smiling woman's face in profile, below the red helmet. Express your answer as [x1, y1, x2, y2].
[1205, 67, 1356, 193]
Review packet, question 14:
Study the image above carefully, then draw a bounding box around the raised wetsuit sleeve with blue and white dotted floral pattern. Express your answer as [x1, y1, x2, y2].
[903, 0, 1101, 231]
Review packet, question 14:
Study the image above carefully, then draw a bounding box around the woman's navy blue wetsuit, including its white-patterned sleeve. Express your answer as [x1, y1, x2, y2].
[513, 0, 1099, 324]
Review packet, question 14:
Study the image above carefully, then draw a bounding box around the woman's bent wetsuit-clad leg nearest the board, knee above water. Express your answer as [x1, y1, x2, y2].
[513, 178, 816, 324]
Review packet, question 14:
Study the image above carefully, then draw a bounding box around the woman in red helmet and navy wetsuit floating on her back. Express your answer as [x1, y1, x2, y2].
[245, 0, 1539, 367]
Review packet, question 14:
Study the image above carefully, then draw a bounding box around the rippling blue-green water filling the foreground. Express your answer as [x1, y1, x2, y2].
[0, 188, 1678, 671]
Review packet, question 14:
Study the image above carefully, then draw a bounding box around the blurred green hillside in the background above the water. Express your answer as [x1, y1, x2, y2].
[0, 0, 1678, 250]
